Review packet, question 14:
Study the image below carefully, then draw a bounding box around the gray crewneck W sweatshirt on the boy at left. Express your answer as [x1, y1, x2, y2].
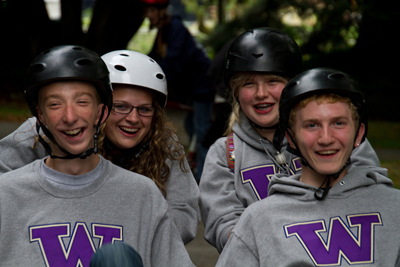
[0, 157, 194, 267]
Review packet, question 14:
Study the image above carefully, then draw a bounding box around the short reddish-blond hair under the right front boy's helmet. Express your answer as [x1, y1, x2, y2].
[288, 94, 360, 134]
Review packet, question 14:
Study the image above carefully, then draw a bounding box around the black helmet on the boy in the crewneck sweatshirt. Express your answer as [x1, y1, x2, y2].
[25, 45, 112, 117]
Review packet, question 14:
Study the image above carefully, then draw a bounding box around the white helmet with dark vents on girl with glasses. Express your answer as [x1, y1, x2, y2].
[101, 50, 168, 108]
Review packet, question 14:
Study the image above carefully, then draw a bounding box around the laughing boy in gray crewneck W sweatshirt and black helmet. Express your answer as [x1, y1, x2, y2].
[0, 46, 193, 266]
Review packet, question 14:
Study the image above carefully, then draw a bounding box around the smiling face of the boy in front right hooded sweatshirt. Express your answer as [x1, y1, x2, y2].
[288, 97, 365, 186]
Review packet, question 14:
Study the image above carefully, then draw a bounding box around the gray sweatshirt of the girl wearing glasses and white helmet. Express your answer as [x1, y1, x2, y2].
[0, 117, 200, 244]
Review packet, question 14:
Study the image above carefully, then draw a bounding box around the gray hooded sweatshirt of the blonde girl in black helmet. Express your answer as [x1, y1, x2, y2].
[200, 112, 380, 252]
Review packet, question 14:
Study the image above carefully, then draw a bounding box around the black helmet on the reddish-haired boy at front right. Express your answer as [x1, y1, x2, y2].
[279, 68, 368, 144]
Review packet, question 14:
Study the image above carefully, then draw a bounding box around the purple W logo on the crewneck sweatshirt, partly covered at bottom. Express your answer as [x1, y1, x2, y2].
[29, 222, 122, 267]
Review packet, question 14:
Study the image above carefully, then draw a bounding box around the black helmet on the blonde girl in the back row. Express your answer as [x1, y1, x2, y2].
[224, 28, 302, 88]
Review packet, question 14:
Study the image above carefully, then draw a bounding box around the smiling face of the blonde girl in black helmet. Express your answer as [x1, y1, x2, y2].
[237, 74, 286, 130]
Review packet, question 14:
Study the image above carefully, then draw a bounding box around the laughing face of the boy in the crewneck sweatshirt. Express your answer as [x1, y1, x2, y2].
[37, 81, 103, 156]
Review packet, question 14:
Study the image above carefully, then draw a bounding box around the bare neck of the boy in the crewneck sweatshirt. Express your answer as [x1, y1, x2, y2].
[46, 154, 100, 175]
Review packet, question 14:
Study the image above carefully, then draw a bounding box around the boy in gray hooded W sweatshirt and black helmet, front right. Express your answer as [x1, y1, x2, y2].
[217, 68, 400, 266]
